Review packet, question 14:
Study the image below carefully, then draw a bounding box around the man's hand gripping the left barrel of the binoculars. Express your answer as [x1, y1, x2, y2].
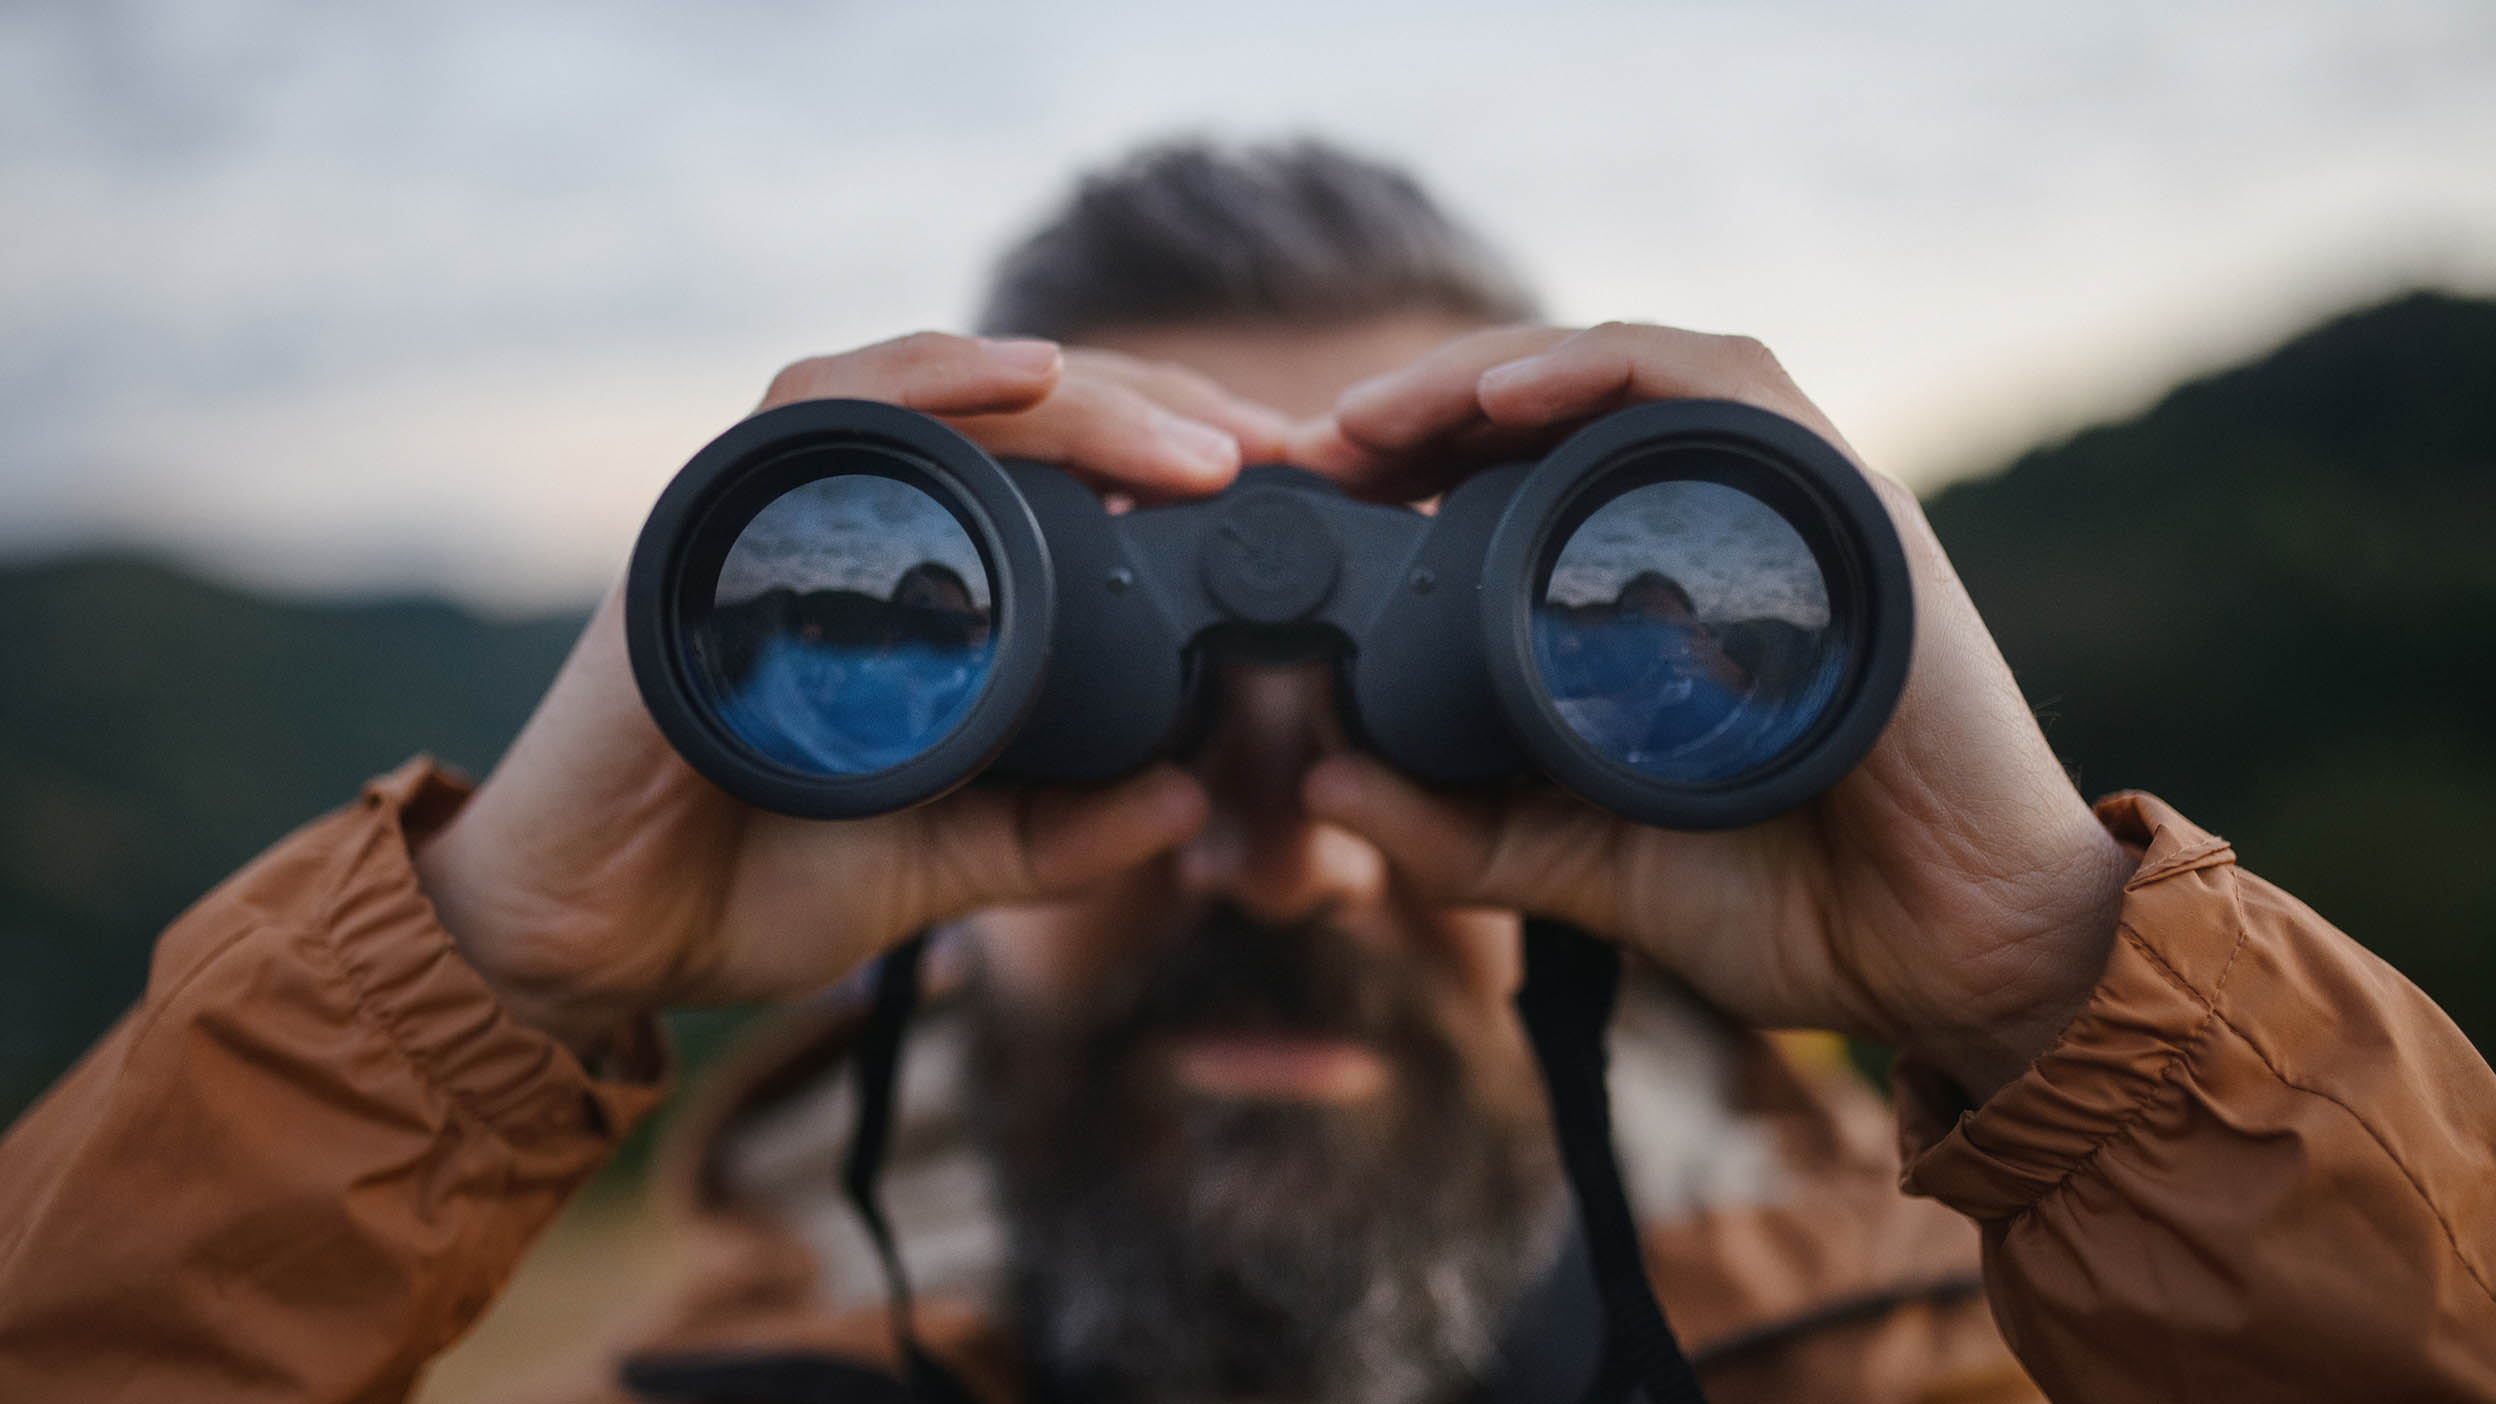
[417, 332, 1288, 1049]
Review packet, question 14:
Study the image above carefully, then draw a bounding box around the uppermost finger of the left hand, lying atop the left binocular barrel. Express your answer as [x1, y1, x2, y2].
[759, 332, 1066, 415]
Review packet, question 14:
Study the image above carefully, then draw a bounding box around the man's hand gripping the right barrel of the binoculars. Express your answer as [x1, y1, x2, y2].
[1293, 322, 2134, 1099]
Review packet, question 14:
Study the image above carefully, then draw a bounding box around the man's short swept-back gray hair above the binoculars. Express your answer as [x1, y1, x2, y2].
[978, 140, 1535, 340]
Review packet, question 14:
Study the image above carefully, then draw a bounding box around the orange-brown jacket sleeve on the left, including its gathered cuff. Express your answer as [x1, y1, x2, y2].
[0, 762, 664, 1402]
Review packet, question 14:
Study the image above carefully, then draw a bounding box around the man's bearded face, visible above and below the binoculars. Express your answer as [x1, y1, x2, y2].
[973, 317, 1560, 1399]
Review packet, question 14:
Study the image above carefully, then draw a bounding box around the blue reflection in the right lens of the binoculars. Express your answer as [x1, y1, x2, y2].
[1533, 482, 1845, 784]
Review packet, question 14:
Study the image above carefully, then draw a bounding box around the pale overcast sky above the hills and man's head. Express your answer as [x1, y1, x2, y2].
[0, 0, 2496, 607]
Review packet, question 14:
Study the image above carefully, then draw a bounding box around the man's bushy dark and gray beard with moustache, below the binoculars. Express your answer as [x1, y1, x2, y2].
[971, 899, 1567, 1404]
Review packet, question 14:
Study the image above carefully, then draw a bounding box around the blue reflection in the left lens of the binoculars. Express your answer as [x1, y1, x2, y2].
[694, 475, 996, 774]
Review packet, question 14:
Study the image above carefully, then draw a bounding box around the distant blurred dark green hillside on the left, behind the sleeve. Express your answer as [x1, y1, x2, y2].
[0, 557, 579, 1119]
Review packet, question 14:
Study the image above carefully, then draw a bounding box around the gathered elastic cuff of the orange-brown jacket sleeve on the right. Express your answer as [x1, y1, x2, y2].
[1897, 792, 2244, 1219]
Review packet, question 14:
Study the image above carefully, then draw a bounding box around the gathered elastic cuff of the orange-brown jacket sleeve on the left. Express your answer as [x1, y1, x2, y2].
[324, 757, 666, 1174]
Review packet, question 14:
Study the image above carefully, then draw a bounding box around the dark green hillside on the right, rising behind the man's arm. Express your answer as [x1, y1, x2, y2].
[1929, 295, 2496, 1049]
